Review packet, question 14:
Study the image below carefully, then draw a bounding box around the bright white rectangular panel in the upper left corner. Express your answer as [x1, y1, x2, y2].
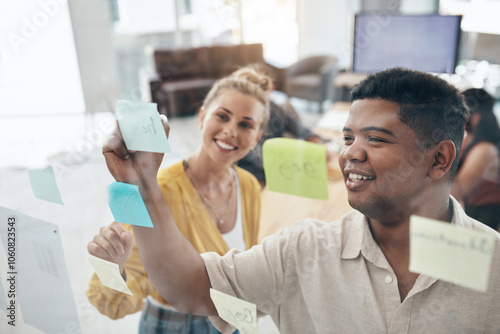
[0, 0, 85, 117]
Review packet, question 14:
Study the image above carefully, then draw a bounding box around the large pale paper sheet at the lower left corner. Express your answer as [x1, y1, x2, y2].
[0, 207, 81, 334]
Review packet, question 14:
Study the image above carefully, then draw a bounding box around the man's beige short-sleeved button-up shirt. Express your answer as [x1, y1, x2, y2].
[203, 199, 500, 334]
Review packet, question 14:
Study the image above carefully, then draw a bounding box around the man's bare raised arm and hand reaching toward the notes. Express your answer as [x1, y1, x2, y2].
[103, 117, 217, 315]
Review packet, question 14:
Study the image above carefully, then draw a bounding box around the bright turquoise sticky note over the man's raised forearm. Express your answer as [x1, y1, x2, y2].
[108, 182, 153, 227]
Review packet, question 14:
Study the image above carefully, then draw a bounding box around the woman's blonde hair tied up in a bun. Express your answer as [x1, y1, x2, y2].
[203, 68, 272, 129]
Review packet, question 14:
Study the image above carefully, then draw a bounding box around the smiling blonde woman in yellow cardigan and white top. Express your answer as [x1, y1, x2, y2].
[87, 73, 271, 333]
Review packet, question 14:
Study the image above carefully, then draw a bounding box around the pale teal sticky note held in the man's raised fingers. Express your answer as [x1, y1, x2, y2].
[115, 100, 171, 153]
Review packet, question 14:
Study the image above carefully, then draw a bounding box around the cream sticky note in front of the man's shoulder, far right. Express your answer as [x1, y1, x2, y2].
[409, 216, 495, 292]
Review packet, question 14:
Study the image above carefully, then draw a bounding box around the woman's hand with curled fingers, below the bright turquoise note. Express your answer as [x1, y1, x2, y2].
[87, 222, 134, 278]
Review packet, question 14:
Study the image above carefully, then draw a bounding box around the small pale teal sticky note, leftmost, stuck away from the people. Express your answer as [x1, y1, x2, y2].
[28, 166, 64, 205]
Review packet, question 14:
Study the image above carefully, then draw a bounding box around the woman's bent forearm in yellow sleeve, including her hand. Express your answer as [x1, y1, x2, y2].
[86, 222, 154, 319]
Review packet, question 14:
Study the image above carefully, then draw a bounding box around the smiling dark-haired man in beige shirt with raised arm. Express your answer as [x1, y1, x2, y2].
[101, 68, 500, 334]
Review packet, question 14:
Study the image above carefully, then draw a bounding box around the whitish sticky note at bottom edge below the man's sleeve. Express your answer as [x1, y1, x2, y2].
[210, 289, 257, 334]
